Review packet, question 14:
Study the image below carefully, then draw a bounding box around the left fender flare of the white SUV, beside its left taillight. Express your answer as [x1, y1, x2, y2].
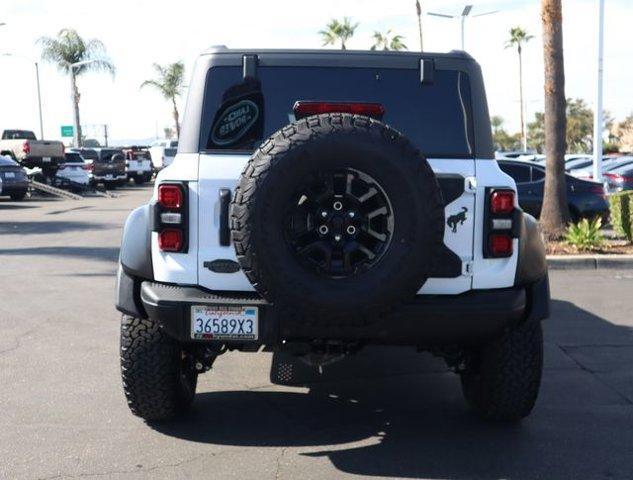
[115, 205, 154, 318]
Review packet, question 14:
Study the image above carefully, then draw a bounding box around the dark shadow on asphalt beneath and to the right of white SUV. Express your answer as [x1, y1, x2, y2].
[152, 301, 633, 480]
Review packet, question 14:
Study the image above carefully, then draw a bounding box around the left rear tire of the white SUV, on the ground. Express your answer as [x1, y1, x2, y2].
[121, 315, 198, 421]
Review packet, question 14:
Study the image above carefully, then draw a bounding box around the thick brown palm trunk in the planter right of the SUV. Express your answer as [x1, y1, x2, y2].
[541, 0, 570, 238]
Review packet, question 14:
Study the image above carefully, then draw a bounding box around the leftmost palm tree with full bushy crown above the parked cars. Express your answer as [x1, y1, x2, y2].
[37, 28, 115, 147]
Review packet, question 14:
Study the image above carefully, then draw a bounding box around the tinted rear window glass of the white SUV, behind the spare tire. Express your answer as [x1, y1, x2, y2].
[200, 63, 472, 158]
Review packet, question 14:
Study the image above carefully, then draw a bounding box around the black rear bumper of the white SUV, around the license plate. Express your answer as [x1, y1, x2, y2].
[135, 274, 549, 347]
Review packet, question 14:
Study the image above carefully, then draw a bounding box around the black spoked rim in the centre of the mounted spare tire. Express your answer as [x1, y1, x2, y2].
[285, 169, 394, 278]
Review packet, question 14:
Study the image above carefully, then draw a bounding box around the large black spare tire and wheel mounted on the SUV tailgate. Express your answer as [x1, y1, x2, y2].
[231, 114, 444, 325]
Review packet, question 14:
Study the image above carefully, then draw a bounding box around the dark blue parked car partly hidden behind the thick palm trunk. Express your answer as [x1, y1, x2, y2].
[498, 160, 609, 222]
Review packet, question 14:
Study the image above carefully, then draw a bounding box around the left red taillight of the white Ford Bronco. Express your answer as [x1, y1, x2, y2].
[154, 183, 188, 253]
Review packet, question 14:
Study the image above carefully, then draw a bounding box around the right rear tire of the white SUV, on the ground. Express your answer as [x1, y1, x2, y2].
[461, 321, 543, 422]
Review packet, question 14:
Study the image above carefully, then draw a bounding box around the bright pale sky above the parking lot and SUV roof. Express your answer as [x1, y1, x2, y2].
[0, 0, 633, 144]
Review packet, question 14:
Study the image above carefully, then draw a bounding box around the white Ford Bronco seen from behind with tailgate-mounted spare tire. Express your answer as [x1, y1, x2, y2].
[116, 47, 549, 421]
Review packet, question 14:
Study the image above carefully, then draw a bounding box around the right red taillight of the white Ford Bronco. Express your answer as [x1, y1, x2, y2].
[483, 188, 520, 258]
